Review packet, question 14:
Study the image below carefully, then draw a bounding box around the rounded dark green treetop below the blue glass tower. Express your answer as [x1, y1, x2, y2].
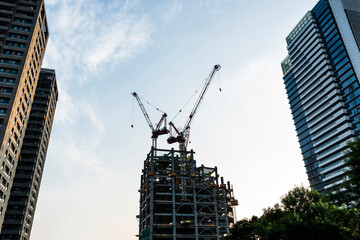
[227, 187, 360, 240]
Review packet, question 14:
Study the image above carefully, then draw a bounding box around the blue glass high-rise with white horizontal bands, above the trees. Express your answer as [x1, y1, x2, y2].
[281, 0, 360, 191]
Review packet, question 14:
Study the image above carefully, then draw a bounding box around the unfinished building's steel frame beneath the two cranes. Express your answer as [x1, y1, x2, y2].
[137, 148, 237, 240]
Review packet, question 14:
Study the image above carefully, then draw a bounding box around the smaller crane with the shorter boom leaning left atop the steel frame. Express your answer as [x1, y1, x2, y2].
[131, 92, 169, 148]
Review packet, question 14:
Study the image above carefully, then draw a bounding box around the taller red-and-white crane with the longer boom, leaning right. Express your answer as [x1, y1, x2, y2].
[167, 64, 221, 151]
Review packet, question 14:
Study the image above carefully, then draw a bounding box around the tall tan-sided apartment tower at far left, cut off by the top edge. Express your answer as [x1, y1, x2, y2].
[0, 0, 48, 231]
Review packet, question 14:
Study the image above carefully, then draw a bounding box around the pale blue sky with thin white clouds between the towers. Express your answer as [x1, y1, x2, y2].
[31, 0, 317, 240]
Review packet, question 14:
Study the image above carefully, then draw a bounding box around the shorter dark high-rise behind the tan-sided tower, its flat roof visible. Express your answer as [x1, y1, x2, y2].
[0, 69, 58, 240]
